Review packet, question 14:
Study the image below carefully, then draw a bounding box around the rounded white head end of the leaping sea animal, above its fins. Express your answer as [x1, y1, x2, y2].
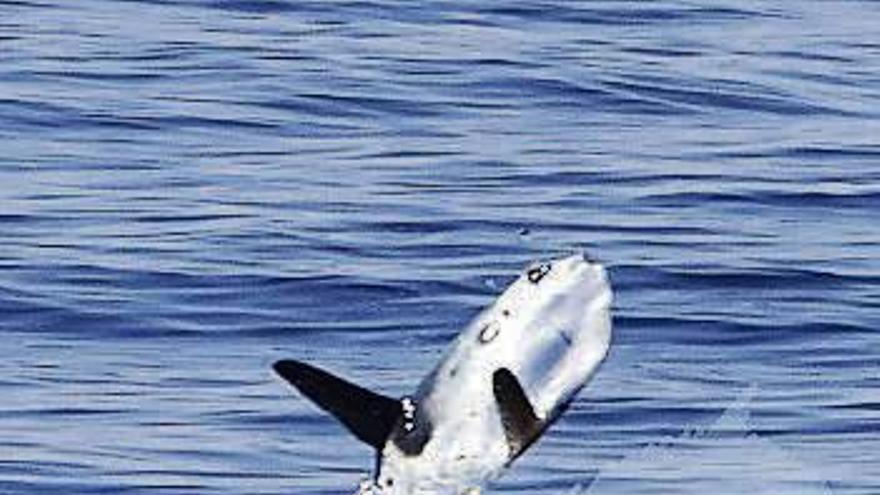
[478, 254, 613, 423]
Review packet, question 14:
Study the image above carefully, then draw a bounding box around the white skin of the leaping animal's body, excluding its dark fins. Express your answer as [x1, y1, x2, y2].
[373, 256, 612, 495]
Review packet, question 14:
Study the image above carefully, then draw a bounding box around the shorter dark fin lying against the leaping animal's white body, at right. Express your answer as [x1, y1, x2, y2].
[492, 368, 545, 462]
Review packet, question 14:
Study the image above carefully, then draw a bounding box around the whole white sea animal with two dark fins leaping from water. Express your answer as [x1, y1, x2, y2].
[275, 255, 612, 495]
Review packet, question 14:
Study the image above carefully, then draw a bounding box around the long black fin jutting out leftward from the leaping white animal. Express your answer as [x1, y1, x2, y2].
[272, 359, 403, 451]
